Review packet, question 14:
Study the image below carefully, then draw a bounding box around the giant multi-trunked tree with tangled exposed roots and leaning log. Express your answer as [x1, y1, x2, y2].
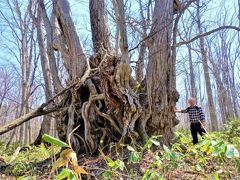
[1, 0, 182, 153]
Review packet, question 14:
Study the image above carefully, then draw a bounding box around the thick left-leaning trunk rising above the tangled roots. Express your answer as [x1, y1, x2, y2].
[53, 0, 87, 81]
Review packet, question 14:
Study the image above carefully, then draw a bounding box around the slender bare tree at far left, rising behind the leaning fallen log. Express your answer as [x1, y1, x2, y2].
[0, 0, 38, 143]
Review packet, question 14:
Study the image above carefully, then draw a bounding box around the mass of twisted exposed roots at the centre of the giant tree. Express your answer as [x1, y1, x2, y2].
[54, 49, 145, 153]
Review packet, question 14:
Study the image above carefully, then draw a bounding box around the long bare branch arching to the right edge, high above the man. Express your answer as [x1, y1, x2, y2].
[176, 26, 240, 47]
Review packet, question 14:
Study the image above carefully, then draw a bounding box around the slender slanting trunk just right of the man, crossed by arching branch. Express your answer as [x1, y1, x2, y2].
[197, 0, 218, 131]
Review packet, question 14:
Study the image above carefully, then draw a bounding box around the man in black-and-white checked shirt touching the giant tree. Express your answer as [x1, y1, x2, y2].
[174, 98, 206, 144]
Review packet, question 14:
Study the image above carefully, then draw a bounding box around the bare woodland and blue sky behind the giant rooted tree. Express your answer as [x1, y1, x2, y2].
[0, 0, 240, 144]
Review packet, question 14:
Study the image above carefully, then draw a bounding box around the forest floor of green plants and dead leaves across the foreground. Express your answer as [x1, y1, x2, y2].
[0, 120, 240, 180]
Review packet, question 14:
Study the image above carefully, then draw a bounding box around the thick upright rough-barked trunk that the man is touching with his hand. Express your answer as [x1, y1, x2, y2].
[147, 0, 179, 145]
